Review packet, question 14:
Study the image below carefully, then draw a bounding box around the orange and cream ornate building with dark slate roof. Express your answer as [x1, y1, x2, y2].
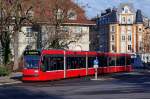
[92, 4, 145, 53]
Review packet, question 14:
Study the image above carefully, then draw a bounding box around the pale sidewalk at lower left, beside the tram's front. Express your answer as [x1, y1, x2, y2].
[0, 72, 22, 86]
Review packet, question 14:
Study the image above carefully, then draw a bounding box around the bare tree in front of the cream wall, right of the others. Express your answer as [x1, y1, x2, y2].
[38, 0, 85, 49]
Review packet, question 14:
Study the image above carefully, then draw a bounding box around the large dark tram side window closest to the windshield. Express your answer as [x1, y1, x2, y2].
[44, 56, 64, 71]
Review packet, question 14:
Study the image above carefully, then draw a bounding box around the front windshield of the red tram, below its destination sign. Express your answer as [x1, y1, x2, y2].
[24, 55, 40, 69]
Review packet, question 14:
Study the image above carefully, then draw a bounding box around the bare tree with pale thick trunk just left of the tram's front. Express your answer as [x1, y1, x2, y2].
[1, 0, 32, 70]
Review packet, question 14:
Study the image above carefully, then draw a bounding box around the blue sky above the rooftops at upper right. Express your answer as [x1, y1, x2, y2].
[75, 0, 150, 18]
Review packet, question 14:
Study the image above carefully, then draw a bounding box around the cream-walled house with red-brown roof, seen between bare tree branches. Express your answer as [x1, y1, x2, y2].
[15, 0, 95, 55]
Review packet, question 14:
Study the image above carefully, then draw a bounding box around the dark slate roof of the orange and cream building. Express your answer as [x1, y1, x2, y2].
[94, 3, 144, 25]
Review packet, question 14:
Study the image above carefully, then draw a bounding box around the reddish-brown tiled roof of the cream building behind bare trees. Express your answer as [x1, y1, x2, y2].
[24, 0, 95, 25]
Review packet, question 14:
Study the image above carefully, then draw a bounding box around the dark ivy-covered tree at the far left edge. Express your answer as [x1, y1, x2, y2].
[0, 0, 11, 66]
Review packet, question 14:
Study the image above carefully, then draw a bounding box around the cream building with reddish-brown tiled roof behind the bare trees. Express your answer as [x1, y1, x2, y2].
[0, 0, 95, 63]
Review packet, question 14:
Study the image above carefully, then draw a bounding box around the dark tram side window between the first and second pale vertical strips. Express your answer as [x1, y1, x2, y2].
[66, 57, 86, 69]
